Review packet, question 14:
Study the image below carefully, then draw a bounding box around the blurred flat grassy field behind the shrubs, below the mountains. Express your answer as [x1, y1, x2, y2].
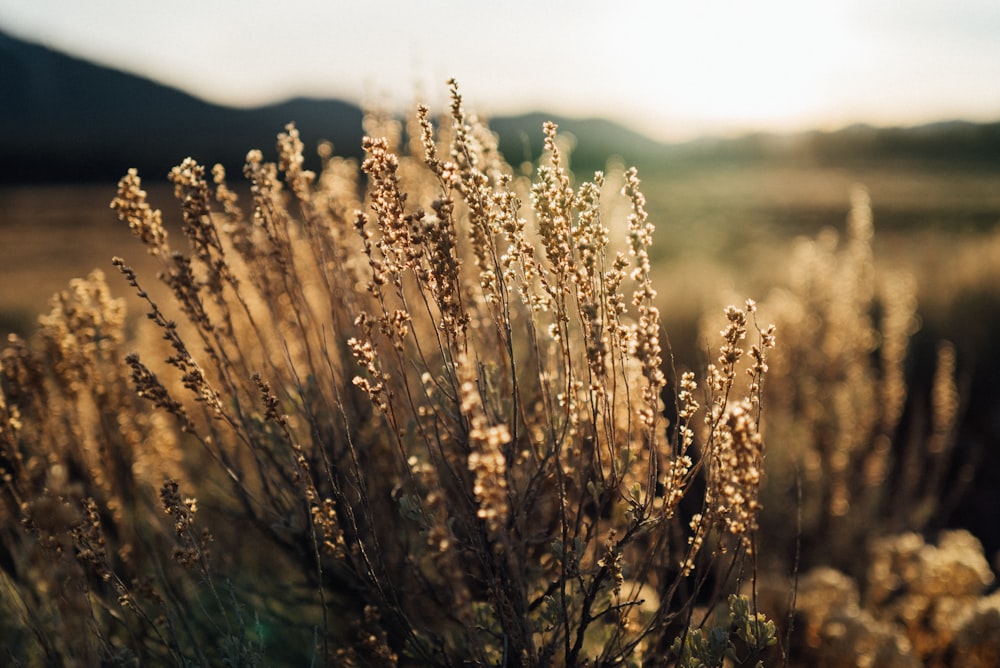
[0, 164, 1000, 396]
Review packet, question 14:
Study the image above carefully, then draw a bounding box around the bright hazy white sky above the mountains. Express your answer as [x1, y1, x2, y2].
[0, 0, 1000, 140]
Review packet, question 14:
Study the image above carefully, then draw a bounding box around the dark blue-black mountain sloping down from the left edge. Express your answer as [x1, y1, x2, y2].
[0, 33, 362, 183]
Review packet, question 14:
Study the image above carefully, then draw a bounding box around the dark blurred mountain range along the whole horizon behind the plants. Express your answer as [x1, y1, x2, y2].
[0, 32, 1000, 183]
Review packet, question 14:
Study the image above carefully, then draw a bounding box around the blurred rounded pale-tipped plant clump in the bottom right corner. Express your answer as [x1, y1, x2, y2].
[798, 530, 1000, 668]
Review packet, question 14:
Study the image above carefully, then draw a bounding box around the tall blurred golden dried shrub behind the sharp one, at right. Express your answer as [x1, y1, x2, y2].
[763, 186, 961, 575]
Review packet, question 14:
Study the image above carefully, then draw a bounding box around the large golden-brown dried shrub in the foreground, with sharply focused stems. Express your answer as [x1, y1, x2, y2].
[0, 84, 774, 666]
